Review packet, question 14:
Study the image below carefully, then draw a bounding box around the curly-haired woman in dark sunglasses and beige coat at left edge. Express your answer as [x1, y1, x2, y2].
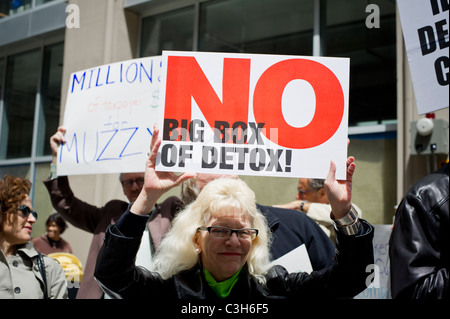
[0, 175, 67, 299]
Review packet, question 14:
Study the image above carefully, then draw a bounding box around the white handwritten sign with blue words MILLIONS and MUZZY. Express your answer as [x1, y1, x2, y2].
[57, 57, 161, 175]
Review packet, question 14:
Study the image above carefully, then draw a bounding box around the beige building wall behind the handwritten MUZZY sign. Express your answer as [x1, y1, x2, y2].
[56, 0, 139, 263]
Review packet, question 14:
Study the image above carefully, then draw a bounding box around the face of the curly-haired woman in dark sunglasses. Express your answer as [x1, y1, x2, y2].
[2, 195, 36, 246]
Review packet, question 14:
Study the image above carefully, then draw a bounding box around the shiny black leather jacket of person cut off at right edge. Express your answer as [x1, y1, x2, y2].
[389, 164, 450, 299]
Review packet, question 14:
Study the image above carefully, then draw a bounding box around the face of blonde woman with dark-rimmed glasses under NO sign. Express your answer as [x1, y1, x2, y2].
[195, 212, 252, 282]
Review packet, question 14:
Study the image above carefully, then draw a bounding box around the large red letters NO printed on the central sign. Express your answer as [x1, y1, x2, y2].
[164, 56, 344, 149]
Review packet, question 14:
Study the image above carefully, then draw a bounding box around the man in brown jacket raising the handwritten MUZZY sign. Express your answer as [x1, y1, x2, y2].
[44, 127, 182, 299]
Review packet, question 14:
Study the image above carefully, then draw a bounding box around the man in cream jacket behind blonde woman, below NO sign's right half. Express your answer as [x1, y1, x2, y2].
[275, 178, 362, 243]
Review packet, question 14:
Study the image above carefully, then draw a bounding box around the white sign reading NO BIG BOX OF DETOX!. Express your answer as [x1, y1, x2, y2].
[157, 51, 350, 179]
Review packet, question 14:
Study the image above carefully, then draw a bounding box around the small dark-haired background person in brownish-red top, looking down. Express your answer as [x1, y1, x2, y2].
[31, 213, 73, 255]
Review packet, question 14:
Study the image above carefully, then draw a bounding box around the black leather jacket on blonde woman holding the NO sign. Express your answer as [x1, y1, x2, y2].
[95, 214, 373, 302]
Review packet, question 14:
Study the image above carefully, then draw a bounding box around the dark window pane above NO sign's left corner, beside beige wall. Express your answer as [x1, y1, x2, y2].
[141, 7, 194, 57]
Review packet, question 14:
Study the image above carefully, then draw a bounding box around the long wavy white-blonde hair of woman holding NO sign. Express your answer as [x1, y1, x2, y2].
[153, 178, 271, 284]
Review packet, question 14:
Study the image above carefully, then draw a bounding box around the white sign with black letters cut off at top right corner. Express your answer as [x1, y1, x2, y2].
[397, 0, 450, 114]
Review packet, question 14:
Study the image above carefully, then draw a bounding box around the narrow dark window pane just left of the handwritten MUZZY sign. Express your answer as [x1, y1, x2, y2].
[36, 43, 64, 156]
